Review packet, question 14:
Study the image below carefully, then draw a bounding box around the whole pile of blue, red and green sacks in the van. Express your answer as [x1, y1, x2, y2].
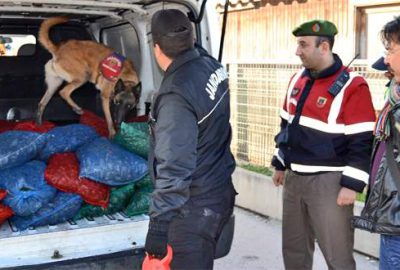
[0, 111, 153, 230]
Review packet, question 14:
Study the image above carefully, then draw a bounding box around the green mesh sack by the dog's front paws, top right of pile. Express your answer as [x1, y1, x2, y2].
[114, 122, 149, 159]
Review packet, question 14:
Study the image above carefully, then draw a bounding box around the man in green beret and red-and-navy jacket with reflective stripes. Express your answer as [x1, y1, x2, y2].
[272, 20, 375, 270]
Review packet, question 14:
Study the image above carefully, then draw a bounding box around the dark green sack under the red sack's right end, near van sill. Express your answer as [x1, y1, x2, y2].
[74, 184, 135, 220]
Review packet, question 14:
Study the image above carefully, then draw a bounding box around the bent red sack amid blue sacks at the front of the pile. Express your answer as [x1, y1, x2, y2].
[44, 153, 110, 208]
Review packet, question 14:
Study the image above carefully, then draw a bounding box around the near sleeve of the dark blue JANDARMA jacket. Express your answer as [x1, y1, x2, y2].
[149, 93, 198, 220]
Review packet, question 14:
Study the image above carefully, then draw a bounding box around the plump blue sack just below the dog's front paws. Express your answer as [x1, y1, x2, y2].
[76, 138, 148, 186]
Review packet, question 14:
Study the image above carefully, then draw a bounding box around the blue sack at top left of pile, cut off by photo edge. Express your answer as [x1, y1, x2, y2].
[0, 130, 49, 170]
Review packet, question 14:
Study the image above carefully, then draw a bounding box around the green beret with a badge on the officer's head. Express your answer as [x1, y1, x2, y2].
[292, 20, 337, 37]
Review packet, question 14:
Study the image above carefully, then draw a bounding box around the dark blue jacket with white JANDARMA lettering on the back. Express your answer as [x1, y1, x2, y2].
[149, 49, 235, 220]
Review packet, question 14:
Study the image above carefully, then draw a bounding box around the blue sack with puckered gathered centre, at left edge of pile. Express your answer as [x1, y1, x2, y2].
[0, 160, 57, 216]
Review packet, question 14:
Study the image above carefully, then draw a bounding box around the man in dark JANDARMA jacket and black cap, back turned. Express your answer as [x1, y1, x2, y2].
[145, 9, 236, 269]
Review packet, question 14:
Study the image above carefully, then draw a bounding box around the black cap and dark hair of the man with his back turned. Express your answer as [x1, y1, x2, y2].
[151, 9, 194, 58]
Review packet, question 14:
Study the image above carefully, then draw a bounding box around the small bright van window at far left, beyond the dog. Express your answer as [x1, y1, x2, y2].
[0, 34, 36, 56]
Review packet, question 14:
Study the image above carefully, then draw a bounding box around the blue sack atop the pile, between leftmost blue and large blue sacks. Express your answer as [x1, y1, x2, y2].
[39, 124, 99, 161]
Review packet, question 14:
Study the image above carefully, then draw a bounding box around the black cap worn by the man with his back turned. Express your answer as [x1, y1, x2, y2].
[151, 9, 193, 40]
